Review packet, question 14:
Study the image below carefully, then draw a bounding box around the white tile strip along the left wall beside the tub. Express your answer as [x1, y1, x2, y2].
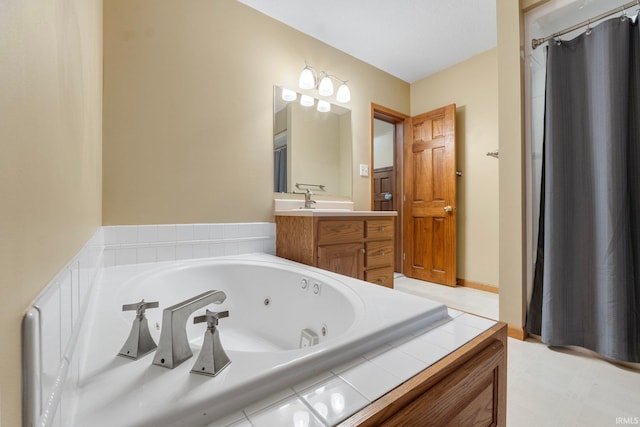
[22, 228, 104, 427]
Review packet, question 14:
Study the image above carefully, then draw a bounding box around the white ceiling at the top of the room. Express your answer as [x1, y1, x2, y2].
[238, 0, 496, 83]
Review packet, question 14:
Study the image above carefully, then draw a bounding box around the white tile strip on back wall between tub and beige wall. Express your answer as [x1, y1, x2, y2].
[104, 222, 276, 267]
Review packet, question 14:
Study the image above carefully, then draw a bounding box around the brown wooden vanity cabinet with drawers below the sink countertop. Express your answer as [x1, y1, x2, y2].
[276, 215, 395, 288]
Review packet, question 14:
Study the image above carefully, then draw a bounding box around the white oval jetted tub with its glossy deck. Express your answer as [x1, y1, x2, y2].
[73, 254, 450, 427]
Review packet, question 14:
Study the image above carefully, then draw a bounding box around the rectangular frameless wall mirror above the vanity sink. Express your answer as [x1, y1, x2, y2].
[273, 86, 352, 198]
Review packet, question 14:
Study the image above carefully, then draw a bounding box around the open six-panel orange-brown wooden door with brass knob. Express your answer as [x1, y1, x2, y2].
[404, 104, 456, 286]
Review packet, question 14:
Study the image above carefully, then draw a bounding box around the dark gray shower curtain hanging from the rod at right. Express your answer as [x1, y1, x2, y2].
[527, 18, 640, 362]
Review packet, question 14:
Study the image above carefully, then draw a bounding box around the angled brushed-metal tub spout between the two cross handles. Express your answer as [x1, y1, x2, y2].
[153, 291, 227, 369]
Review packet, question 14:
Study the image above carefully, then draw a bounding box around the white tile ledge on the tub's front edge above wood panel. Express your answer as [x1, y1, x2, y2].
[202, 309, 496, 427]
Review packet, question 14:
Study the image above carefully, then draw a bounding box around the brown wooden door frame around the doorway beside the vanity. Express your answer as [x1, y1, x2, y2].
[369, 102, 411, 273]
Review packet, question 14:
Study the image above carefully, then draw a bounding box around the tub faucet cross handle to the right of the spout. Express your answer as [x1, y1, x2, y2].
[191, 310, 231, 377]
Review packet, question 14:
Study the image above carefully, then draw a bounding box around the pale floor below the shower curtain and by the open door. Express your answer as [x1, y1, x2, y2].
[395, 277, 640, 427]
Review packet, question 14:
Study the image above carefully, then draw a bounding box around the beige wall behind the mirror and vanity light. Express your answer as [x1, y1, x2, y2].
[103, 0, 409, 225]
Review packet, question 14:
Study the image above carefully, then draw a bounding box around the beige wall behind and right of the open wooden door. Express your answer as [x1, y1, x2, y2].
[411, 48, 499, 286]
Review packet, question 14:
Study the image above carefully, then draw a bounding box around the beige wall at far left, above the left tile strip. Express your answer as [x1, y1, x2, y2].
[0, 0, 102, 427]
